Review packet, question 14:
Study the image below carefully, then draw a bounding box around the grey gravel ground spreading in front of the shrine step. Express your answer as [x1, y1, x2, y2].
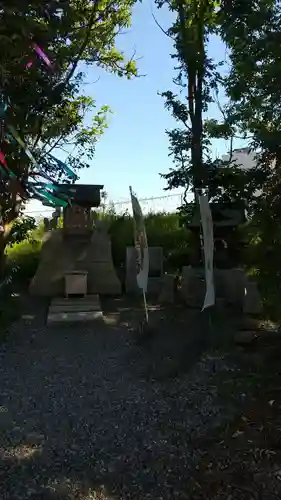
[0, 296, 236, 500]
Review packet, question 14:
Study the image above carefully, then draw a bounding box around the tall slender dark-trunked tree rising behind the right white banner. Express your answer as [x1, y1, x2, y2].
[157, 0, 264, 224]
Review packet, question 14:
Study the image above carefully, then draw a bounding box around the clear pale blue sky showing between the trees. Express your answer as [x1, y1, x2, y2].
[26, 1, 245, 214]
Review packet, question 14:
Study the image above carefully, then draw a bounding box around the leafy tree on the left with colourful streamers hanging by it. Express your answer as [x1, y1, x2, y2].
[0, 0, 136, 270]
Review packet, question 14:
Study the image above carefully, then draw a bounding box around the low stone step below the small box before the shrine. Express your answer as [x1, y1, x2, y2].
[47, 295, 103, 325]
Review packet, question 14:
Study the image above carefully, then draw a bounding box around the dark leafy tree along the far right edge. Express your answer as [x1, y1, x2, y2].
[220, 0, 281, 317]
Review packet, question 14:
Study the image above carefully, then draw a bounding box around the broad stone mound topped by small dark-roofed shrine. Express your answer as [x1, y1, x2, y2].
[30, 184, 121, 297]
